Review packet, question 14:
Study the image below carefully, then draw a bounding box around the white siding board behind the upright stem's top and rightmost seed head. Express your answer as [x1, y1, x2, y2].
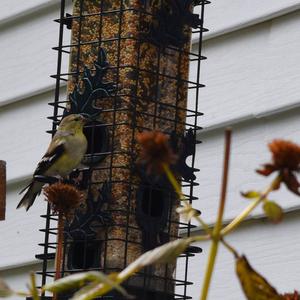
[194, 108, 300, 223]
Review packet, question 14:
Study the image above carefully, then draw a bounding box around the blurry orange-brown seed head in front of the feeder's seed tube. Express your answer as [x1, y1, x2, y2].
[137, 131, 176, 173]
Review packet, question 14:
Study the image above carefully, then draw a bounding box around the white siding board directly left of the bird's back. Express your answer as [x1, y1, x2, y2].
[0, 92, 60, 181]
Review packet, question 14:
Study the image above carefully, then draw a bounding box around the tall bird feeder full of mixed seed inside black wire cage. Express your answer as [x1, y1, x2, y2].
[37, 0, 209, 299]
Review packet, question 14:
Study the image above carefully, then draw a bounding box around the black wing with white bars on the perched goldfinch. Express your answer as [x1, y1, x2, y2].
[34, 137, 65, 175]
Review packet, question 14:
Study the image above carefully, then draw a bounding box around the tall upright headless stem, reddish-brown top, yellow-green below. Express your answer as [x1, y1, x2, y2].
[200, 129, 231, 300]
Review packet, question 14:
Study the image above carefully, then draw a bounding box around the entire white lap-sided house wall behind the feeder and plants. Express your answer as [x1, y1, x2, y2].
[0, 0, 300, 300]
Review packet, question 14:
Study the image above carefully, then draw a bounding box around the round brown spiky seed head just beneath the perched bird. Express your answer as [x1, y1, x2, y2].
[44, 182, 84, 218]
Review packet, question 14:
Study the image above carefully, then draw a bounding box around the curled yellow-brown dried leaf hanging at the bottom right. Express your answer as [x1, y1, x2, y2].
[236, 256, 283, 300]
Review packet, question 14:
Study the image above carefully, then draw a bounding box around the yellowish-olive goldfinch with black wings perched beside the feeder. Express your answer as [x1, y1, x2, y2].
[17, 114, 87, 210]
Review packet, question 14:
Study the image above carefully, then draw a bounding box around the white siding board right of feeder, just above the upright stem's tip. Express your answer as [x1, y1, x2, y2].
[191, 10, 300, 127]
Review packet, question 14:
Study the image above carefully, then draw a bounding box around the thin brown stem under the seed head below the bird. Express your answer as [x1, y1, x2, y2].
[53, 212, 64, 300]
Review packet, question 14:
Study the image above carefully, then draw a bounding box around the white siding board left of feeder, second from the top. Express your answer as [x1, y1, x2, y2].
[0, 5, 70, 107]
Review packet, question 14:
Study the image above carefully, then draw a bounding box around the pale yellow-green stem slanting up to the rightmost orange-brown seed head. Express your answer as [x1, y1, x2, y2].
[221, 176, 281, 236]
